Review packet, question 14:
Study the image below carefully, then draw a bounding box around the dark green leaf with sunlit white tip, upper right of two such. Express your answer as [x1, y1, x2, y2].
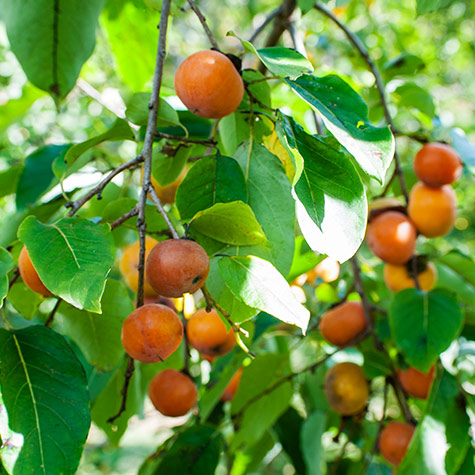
[286, 74, 394, 183]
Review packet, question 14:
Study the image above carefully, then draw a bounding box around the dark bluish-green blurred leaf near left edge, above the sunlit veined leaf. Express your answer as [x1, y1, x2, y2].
[15, 145, 69, 209]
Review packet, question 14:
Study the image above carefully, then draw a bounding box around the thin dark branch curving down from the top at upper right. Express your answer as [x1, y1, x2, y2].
[314, 3, 409, 202]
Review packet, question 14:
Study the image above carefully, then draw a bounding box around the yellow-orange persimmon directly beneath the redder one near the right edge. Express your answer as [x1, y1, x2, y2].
[407, 181, 457, 237]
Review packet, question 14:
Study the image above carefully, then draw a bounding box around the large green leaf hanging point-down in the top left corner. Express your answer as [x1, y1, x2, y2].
[2, 0, 104, 99]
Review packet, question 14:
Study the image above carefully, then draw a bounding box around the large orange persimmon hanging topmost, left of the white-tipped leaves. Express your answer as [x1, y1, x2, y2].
[175, 50, 244, 119]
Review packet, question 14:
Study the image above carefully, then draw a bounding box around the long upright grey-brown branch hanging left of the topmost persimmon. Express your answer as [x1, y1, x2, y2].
[108, 0, 171, 423]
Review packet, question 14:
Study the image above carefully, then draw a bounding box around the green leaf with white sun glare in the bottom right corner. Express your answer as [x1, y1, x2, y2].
[398, 371, 471, 475]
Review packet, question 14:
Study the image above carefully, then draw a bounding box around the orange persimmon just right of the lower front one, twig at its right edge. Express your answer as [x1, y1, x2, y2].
[186, 308, 236, 356]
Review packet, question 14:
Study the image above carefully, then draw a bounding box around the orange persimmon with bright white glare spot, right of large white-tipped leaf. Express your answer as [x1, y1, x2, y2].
[366, 211, 417, 264]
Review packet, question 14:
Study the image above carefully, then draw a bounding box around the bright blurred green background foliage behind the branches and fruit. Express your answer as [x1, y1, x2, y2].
[0, 0, 475, 475]
